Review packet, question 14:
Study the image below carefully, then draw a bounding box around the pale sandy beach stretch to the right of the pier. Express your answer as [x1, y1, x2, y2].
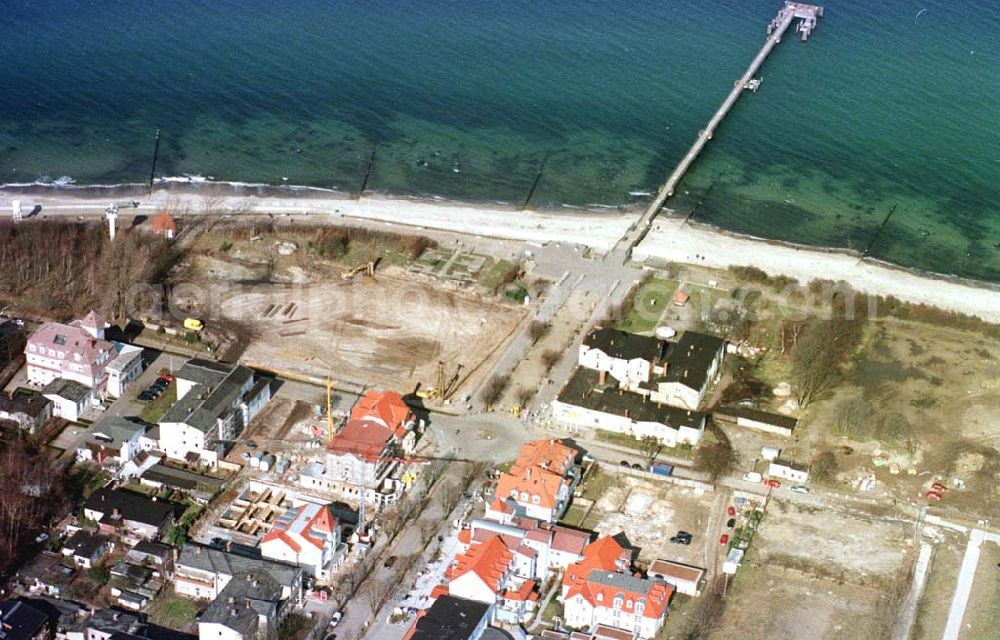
[632, 217, 1000, 322]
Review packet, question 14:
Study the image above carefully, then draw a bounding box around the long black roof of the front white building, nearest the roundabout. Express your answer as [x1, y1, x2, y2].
[559, 367, 705, 429]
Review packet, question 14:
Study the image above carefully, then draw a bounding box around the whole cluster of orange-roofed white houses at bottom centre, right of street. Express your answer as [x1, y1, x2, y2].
[408, 440, 692, 639]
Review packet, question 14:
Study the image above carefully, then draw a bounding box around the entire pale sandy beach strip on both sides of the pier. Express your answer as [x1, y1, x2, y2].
[0, 181, 1000, 322]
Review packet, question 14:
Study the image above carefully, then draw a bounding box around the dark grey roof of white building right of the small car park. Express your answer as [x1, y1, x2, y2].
[160, 359, 253, 433]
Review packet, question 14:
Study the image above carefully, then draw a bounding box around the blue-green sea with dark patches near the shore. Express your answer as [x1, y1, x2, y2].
[0, 0, 1000, 282]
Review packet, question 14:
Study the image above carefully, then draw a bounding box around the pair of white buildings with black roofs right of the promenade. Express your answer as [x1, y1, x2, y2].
[552, 328, 726, 447]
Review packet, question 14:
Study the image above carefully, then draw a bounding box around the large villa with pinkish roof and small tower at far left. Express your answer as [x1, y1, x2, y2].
[24, 311, 118, 395]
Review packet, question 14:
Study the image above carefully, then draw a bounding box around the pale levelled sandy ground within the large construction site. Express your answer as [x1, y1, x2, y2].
[222, 276, 523, 392]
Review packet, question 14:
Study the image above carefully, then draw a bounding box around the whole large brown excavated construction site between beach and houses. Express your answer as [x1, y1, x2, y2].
[174, 220, 525, 398]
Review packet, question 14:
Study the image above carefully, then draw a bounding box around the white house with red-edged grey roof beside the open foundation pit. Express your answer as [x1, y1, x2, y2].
[260, 502, 341, 580]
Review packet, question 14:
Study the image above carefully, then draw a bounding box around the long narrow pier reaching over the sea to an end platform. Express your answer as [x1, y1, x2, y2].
[643, 2, 823, 238]
